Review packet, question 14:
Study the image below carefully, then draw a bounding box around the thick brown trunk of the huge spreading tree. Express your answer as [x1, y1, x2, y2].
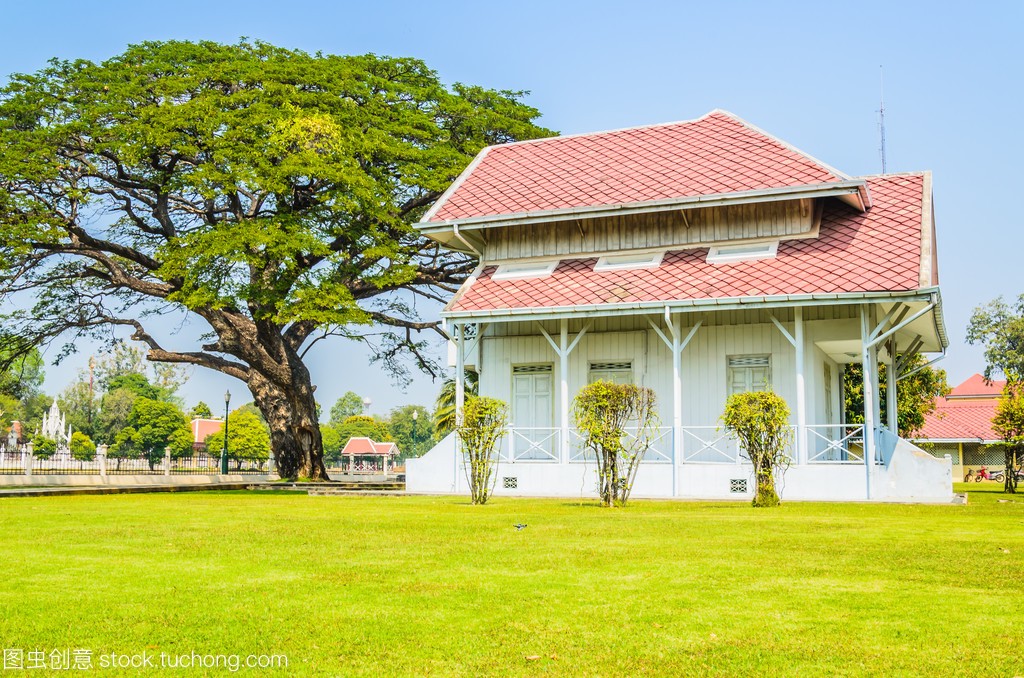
[249, 368, 331, 480]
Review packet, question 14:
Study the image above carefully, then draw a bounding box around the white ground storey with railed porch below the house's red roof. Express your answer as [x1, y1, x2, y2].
[407, 296, 952, 501]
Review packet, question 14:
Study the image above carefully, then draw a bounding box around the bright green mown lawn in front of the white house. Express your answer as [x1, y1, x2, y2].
[0, 483, 1024, 676]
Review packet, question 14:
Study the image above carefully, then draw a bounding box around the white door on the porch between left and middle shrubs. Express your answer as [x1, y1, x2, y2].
[512, 365, 558, 459]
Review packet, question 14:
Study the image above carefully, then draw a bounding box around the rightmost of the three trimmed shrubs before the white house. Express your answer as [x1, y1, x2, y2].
[722, 391, 793, 506]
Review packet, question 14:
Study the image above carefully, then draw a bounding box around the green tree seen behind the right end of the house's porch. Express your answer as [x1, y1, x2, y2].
[843, 353, 950, 437]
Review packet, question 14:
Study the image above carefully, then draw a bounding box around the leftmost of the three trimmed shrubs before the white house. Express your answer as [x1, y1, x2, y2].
[456, 396, 509, 505]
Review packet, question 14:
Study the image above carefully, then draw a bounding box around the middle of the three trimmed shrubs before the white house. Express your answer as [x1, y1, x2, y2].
[572, 380, 658, 506]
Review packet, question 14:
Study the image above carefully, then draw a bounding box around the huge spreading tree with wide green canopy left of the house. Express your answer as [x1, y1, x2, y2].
[0, 42, 551, 478]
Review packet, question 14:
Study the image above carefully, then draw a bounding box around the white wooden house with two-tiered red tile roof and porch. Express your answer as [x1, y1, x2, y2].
[407, 111, 952, 501]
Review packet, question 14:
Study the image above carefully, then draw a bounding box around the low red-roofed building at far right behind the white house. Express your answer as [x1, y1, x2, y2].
[915, 374, 1007, 476]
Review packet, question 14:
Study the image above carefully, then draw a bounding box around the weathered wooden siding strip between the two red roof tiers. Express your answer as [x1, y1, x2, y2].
[481, 200, 819, 262]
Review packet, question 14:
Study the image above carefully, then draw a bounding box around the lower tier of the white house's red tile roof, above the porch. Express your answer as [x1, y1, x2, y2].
[445, 174, 925, 312]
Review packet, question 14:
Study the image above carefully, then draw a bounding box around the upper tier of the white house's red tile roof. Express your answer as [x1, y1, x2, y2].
[427, 111, 848, 221]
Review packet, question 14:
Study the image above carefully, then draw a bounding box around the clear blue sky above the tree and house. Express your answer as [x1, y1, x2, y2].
[0, 0, 1024, 413]
